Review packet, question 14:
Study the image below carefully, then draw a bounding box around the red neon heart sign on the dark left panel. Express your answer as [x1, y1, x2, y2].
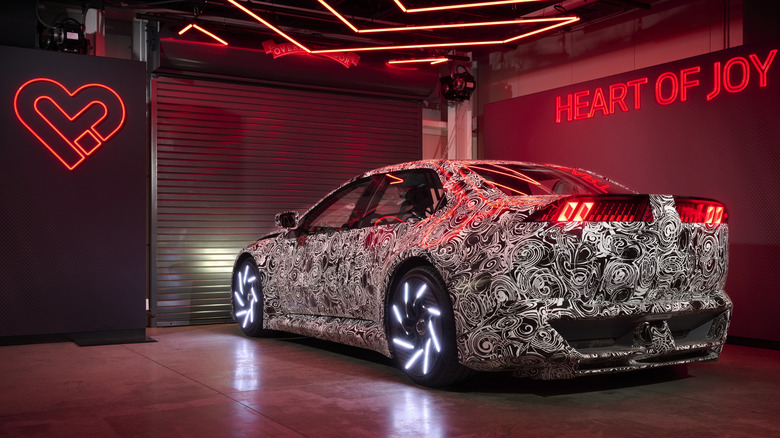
[14, 78, 126, 170]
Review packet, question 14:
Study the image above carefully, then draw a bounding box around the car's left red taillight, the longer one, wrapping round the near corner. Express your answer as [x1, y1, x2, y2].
[527, 195, 653, 222]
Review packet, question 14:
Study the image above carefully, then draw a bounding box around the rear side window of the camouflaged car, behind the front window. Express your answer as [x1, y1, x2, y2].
[360, 169, 445, 227]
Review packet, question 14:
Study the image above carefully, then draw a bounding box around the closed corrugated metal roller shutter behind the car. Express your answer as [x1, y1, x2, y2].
[151, 77, 422, 326]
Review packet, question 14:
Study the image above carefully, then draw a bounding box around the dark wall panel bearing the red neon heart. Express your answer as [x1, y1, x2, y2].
[0, 47, 148, 336]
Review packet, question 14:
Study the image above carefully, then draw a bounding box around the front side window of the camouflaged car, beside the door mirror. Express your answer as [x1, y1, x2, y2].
[302, 178, 371, 233]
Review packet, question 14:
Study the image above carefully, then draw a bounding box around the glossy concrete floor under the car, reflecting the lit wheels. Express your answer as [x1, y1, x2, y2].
[0, 324, 780, 438]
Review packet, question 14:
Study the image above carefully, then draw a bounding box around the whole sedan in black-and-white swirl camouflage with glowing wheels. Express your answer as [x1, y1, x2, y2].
[232, 160, 732, 386]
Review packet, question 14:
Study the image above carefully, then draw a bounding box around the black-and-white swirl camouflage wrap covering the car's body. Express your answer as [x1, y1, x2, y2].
[239, 161, 731, 379]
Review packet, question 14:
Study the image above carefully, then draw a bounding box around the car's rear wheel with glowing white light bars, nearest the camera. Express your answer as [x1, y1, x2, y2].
[387, 266, 473, 388]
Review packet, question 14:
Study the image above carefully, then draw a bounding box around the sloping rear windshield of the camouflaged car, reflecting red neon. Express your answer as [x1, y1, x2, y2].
[465, 163, 634, 196]
